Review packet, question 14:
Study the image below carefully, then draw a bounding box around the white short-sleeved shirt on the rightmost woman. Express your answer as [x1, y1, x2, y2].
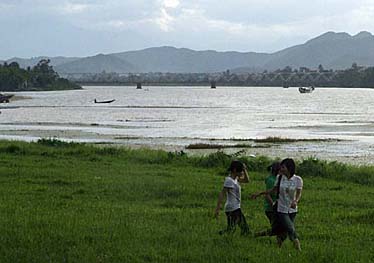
[274, 175, 303, 213]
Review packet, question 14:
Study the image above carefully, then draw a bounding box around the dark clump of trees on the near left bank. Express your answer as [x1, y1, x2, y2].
[0, 59, 81, 91]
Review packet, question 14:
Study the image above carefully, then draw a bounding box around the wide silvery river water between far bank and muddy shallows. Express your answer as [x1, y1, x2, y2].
[0, 87, 374, 161]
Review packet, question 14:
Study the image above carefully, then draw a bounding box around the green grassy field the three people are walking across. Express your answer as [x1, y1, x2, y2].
[0, 140, 374, 262]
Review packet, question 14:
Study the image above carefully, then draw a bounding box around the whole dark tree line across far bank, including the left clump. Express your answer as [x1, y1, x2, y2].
[0, 59, 374, 91]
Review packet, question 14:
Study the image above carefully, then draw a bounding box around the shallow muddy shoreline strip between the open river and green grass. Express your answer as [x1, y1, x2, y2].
[0, 129, 374, 165]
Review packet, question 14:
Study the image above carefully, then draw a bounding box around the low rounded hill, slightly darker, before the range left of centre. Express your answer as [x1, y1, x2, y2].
[55, 54, 139, 73]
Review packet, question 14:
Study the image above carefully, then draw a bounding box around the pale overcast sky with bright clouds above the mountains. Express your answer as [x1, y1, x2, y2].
[0, 0, 374, 59]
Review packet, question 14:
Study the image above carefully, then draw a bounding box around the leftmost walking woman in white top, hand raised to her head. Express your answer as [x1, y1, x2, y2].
[214, 160, 250, 235]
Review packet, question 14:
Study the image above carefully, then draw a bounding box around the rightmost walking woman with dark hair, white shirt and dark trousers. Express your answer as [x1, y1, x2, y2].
[251, 158, 303, 250]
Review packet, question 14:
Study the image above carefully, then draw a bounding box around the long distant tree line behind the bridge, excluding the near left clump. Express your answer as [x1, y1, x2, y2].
[66, 63, 374, 88]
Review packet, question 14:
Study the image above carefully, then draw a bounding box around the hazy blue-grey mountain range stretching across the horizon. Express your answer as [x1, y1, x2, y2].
[7, 31, 374, 74]
